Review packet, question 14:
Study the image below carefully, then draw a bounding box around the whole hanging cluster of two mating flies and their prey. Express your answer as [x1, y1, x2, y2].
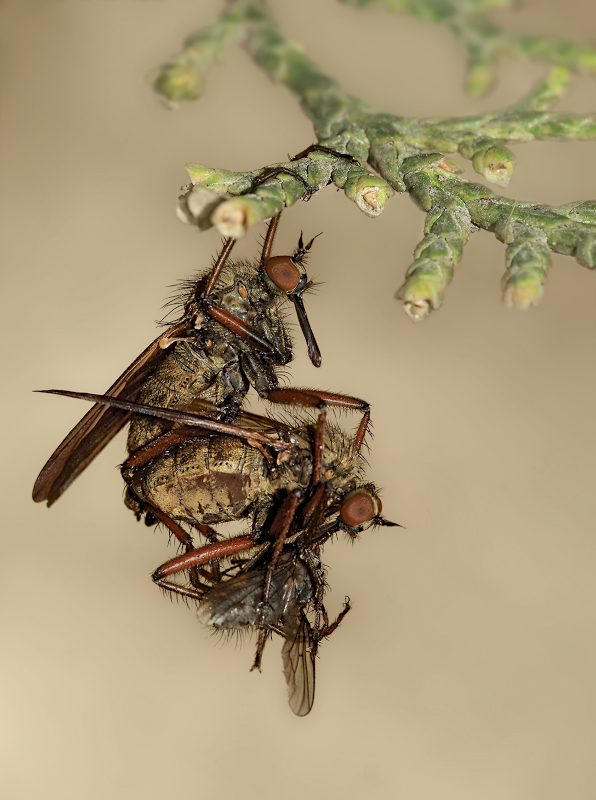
[33, 209, 396, 714]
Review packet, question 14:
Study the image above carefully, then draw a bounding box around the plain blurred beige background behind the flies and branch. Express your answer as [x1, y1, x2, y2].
[0, 0, 596, 800]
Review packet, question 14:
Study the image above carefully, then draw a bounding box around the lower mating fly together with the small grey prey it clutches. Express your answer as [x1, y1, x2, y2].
[40, 389, 393, 715]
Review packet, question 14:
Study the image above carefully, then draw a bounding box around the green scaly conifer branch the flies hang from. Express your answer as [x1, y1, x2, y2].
[155, 0, 596, 321]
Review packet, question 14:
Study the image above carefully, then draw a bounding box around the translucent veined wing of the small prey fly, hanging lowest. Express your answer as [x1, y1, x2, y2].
[281, 611, 315, 717]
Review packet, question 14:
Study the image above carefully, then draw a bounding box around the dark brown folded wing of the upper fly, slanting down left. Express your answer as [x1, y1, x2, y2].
[33, 320, 186, 506]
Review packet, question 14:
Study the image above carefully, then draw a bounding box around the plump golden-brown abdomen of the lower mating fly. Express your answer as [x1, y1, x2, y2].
[129, 436, 269, 525]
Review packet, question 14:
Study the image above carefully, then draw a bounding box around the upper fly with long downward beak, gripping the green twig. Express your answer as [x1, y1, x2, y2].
[33, 212, 321, 512]
